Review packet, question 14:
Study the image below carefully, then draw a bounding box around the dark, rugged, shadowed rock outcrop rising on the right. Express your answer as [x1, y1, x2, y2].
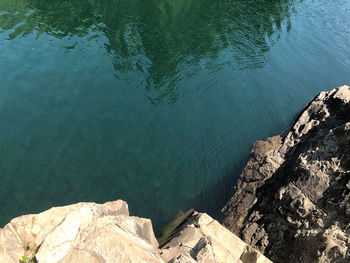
[222, 86, 350, 262]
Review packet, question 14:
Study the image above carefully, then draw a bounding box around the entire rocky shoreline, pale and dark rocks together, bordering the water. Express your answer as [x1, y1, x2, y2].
[0, 86, 350, 263]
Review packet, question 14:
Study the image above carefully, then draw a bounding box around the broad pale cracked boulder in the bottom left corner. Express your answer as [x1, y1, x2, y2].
[0, 200, 164, 263]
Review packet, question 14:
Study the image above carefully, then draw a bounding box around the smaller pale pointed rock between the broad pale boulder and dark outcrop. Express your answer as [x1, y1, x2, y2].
[162, 213, 271, 263]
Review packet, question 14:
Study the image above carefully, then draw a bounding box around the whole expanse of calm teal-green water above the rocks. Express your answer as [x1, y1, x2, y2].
[0, 0, 350, 230]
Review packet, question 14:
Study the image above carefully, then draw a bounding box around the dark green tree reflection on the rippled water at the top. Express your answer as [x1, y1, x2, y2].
[0, 0, 292, 103]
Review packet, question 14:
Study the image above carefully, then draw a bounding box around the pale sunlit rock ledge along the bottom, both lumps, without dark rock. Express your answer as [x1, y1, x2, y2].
[0, 200, 271, 263]
